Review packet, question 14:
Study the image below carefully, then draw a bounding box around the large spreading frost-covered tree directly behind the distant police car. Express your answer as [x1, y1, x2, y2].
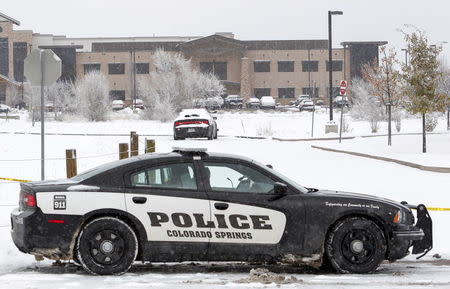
[138, 50, 224, 121]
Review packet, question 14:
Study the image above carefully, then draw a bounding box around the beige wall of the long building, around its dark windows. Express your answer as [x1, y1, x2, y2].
[76, 48, 350, 103]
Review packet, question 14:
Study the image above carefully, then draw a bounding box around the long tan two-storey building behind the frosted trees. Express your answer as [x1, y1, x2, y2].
[0, 13, 387, 103]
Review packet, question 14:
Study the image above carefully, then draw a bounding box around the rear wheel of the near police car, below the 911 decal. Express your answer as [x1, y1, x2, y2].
[76, 217, 139, 275]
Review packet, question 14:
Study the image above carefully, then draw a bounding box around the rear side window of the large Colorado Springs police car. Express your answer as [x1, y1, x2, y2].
[130, 163, 197, 190]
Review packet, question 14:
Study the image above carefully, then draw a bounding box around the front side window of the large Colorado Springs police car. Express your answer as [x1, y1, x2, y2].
[204, 162, 274, 194]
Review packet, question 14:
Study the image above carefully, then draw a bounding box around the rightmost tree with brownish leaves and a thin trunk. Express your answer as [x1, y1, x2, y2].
[403, 29, 448, 153]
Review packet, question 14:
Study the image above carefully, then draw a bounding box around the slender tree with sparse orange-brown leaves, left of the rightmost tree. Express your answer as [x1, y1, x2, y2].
[362, 46, 402, 145]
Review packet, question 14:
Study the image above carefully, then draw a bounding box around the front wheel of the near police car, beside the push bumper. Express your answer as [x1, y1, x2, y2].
[325, 217, 386, 274]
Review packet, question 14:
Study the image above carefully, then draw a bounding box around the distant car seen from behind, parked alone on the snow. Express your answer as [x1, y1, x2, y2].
[173, 108, 218, 140]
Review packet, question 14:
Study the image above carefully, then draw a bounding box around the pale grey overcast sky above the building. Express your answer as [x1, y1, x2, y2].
[0, 0, 450, 59]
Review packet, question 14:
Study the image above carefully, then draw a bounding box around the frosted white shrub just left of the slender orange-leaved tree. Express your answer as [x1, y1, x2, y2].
[350, 78, 384, 132]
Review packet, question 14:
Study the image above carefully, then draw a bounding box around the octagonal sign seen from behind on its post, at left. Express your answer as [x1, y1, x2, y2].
[24, 49, 61, 180]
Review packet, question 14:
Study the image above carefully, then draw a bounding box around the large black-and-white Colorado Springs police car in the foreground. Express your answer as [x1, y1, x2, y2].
[11, 148, 432, 275]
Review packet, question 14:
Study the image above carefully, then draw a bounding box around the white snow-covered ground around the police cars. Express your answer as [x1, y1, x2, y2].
[0, 112, 450, 288]
